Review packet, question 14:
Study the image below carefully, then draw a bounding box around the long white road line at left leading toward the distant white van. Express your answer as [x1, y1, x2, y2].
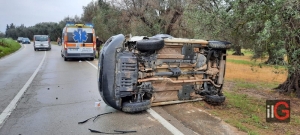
[0, 51, 46, 128]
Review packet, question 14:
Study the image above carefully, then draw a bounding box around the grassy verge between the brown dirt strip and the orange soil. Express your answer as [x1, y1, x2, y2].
[203, 81, 300, 135]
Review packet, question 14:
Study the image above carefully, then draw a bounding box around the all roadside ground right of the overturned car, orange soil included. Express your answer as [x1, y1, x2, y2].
[163, 56, 300, 135]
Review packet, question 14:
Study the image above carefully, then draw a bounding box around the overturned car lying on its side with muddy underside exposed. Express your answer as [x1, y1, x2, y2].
[98, 34, 230, 113]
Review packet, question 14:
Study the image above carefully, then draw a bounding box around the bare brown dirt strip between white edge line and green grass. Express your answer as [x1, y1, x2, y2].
[162, 101, 246, 135]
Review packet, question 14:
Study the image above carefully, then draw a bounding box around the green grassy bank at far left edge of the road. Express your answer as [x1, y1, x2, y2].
[0, 38, 21, 58]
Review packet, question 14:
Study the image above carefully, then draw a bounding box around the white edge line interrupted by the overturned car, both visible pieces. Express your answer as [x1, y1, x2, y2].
[86, 61, 184, 135]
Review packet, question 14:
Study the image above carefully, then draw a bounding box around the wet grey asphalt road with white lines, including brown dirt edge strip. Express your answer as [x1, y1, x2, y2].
[0, 44, 244, 135]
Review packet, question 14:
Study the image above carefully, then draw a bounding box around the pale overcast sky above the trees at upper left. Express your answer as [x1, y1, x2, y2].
[0, 0, 92, 33]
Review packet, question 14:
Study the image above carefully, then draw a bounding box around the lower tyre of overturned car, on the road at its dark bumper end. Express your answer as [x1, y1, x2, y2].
[122, 100, 151, 113]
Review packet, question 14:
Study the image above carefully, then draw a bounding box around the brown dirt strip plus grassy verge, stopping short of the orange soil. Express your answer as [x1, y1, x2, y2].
[162, 81, 300, 135]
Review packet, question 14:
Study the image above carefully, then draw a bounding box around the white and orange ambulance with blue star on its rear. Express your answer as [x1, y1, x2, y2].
[61, 23, 96, 61]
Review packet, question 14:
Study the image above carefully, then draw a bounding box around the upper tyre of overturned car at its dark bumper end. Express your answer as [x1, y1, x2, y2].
[136, 38, 164, 52]
